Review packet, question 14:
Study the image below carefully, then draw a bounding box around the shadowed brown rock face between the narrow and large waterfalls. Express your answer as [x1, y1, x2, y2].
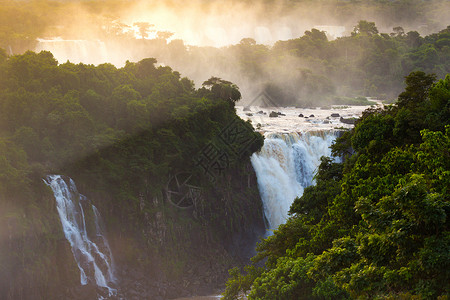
[77, 162, 265, 299]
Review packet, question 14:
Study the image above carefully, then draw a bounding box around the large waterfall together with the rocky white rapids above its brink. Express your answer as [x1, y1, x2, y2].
[236, 103, 382, 230]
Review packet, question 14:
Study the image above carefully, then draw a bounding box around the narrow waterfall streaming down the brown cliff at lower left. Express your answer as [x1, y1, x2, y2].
[45, 175, 116, 296]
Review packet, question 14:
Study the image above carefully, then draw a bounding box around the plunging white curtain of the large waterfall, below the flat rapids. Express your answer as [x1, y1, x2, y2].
[251, 131, 337, 229]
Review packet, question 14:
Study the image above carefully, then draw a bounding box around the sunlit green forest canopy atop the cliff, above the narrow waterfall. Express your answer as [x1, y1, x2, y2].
[0, 50, 262, 195]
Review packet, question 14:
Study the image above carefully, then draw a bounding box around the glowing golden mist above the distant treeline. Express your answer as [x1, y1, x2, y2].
[37, 0, 450, 47]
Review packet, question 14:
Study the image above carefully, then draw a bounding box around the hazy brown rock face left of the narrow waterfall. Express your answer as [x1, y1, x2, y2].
[0, 190, 83, 300]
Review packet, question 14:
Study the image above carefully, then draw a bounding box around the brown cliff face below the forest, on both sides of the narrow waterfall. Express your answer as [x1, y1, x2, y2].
[5, 161, 265, 300]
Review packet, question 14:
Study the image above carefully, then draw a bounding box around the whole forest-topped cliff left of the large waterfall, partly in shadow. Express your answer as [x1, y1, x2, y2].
[0, 50, 264, 299]
